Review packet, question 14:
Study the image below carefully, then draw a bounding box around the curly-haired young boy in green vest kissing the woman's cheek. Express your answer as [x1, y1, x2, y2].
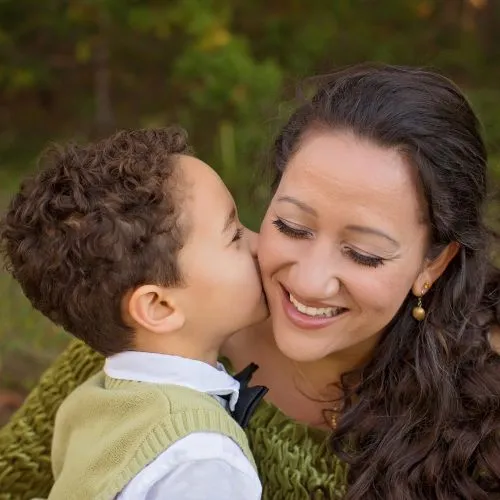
[1, 129, 268, 500]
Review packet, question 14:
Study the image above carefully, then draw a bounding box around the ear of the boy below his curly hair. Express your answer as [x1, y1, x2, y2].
[126, 285, 185, 333]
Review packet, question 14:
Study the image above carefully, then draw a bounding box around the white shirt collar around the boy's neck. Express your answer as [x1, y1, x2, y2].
[104, 351, 240, 411]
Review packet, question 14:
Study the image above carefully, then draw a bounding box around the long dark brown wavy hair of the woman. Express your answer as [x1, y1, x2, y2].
[274, 65, 500, 500]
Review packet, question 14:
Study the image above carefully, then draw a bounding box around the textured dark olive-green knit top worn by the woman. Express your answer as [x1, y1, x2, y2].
[0, 341, 347, 500]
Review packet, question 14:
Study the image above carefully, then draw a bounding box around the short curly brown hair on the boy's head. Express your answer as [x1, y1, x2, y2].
[0, 127, 191, 356]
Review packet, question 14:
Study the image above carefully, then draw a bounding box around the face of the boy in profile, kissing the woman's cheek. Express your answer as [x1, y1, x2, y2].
[178, 156, 268, 347]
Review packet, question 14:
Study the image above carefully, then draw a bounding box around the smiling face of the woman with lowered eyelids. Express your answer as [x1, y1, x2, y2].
[259, 131, 428, 361]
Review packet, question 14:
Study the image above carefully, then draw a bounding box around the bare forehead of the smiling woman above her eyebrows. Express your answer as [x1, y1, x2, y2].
[275, 133, 423, 229]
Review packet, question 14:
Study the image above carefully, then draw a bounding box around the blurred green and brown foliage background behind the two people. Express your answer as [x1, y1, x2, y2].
[0, 0, 500, 422]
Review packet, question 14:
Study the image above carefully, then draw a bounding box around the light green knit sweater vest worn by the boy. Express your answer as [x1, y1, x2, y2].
[49, 371, 255, 500]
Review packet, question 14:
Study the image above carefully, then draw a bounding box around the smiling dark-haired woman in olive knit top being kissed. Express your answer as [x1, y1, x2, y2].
[0, 66, 500, 500]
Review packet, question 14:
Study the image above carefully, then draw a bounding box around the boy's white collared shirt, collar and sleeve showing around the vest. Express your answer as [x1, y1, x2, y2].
[104, 351, 262, 500]
